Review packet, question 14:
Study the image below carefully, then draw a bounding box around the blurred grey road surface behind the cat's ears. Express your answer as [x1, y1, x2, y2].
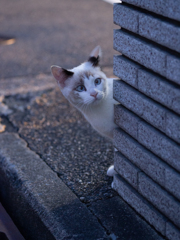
[0, 0, 117, 78]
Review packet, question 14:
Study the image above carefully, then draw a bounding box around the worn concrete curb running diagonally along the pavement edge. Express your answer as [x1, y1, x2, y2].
[0, 133, 107, 240]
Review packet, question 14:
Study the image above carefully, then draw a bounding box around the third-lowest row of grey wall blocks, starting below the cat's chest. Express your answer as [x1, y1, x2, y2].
[114, 129, 180, 200]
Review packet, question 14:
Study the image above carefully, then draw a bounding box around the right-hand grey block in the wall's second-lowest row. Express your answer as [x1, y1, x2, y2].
[138, 173, 180, 227]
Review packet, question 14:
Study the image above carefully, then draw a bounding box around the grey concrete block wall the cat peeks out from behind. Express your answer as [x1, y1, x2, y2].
[113, 0, 180, 240]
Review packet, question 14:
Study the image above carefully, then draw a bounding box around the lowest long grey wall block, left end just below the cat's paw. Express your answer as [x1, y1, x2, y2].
[113, 175, 167, 235]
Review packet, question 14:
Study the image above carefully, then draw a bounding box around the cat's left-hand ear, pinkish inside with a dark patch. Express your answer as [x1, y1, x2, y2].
[51, 66, 74, 88]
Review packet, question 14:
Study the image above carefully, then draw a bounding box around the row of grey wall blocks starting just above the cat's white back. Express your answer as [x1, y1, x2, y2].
[114, 55, 180, 114]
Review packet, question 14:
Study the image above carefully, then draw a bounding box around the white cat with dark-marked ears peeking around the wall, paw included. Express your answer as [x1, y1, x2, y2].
[51, 46, 118, 176]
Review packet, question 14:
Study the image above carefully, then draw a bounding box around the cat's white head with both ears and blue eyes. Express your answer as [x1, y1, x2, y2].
[51, 46, 107, 109]
